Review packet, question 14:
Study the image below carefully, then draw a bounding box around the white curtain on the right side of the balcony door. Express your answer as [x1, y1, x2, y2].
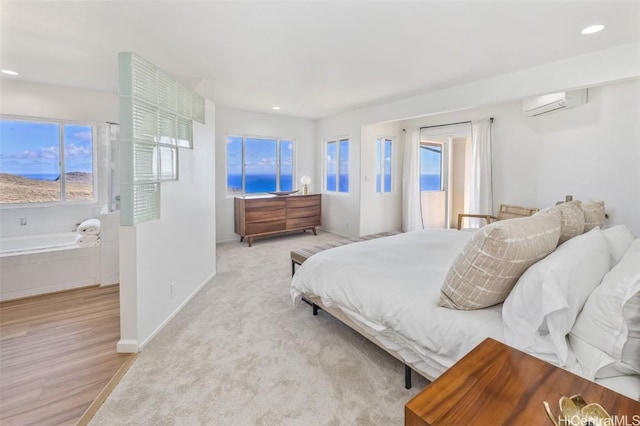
[469, 119, 493, 228]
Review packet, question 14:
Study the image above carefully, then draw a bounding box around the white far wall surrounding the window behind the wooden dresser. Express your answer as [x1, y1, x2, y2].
[215, 108, 316, 241]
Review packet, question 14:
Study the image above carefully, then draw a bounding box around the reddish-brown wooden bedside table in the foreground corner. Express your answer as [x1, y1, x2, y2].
[404, 339, 640, 426]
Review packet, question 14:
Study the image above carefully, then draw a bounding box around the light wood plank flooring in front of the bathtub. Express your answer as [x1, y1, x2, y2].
[0, 285, 134, 426]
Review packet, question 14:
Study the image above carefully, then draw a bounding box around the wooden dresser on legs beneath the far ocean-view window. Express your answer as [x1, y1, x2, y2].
[234, 194, 322, 247]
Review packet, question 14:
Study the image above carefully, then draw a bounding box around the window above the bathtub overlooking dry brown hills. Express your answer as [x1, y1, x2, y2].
[0, 118, 94, 204]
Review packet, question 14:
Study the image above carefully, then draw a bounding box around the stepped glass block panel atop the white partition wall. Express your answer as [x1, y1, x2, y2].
[118, 52, 204, 226]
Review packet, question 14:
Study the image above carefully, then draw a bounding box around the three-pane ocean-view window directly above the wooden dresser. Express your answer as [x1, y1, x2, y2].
[227, 136, 294, 194]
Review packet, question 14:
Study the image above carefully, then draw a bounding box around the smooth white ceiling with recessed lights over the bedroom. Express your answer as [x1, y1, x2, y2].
[0, 0, 640, 118]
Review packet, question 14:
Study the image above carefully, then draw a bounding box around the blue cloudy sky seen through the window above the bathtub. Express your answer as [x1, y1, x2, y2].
[0, 119, 93, 175]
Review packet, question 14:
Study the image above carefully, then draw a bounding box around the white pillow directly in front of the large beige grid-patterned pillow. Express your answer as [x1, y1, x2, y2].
[502, 228, 611, 366]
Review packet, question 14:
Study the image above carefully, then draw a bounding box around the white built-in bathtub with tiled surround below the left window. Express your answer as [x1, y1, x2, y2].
[0, 232, 101, 301]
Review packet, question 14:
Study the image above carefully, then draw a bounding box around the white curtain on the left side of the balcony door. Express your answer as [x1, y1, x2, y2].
[402, 129, 424, 232]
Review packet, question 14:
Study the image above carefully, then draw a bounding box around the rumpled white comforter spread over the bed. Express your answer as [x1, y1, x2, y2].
[291, 230, 504, 378]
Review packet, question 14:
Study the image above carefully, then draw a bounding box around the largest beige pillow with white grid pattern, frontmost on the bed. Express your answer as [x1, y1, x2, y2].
[438, 210, 561, 310]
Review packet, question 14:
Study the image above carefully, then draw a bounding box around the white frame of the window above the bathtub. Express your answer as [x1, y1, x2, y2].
[0, 114, 100, 206]
